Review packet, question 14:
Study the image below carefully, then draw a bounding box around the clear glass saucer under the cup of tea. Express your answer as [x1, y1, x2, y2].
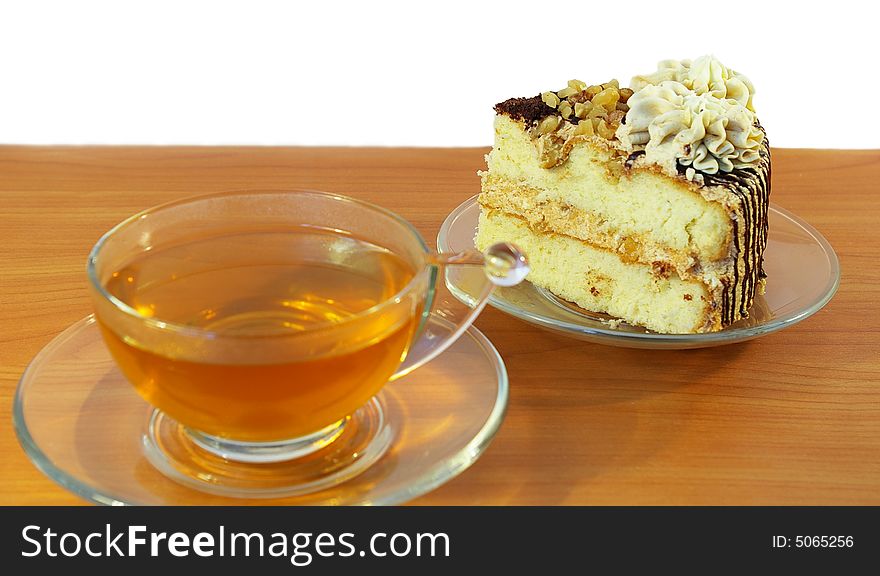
[13, 316, 508, 505]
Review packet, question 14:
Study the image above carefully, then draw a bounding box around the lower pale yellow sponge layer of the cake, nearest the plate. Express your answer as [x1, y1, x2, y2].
[476, 210, 721, 333]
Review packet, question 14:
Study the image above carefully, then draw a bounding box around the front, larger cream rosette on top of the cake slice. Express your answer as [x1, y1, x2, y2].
[617, 80, 764, 174]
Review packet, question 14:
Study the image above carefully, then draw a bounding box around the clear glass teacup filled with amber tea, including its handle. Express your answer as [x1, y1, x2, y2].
[88, 191, 528, 497]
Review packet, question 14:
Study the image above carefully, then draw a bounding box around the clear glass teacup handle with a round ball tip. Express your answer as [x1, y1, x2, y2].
[391, 242, 529, 381]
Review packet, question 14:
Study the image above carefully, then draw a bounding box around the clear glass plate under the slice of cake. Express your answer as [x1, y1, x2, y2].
[437, 196, 840, 349]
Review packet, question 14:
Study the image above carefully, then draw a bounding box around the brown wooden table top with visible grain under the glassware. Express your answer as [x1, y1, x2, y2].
[0, 146, 880, 505]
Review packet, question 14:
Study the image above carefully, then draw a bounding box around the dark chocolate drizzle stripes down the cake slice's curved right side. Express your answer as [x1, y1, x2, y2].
[703, 127, 770, 326]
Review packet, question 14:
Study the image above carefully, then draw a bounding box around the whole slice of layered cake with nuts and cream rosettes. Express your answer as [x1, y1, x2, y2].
[476, 56, 770, 333]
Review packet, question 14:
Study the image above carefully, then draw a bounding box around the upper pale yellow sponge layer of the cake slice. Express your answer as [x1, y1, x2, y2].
[480, 115, 732, 264]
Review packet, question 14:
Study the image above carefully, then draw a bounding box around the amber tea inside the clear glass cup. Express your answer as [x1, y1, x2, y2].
[98, 227, 421, 442]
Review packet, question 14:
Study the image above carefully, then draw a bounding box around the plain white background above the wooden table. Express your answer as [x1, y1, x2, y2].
[0, 0, 880, 148]
